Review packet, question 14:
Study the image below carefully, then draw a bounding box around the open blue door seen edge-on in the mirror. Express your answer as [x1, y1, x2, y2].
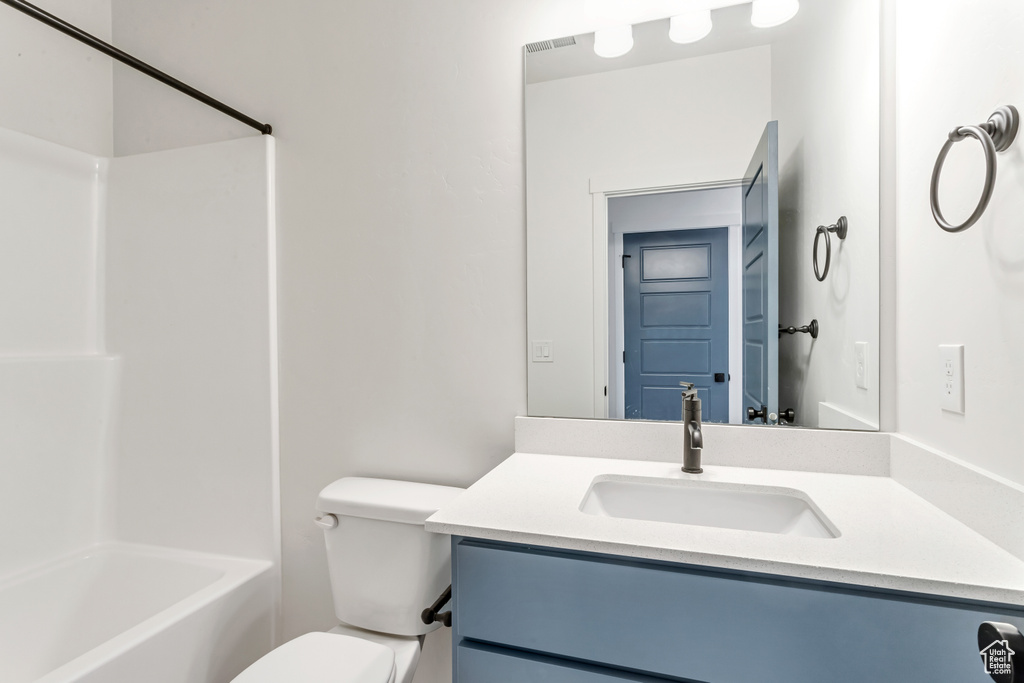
[742, 121, 778, 422]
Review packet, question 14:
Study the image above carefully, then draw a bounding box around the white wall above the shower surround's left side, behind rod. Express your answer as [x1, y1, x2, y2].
[0, 0, 114, 156]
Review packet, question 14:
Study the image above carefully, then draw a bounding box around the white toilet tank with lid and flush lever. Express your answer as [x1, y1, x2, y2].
[316, 477, 463, 636]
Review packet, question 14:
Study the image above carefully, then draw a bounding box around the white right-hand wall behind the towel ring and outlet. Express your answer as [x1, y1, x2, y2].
[896, 0, 1024, 483]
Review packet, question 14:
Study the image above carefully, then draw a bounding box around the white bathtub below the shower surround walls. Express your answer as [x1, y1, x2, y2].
[0, 544, 273, 683]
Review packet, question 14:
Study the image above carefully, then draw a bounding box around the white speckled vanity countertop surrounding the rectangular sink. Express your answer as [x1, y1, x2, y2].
[426, 453, 1024, 605]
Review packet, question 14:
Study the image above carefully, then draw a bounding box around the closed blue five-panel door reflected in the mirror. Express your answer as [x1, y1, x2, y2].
[623, 227, 729, 422]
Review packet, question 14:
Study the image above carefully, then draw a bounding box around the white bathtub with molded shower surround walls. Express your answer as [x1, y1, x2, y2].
[0, 122, 280, 683]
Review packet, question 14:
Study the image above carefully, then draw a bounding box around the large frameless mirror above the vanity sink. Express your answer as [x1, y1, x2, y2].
[524, 0, 880, 429]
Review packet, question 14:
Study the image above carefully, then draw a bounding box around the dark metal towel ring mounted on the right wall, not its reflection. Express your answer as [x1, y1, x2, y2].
[931, 104, 1020, 232]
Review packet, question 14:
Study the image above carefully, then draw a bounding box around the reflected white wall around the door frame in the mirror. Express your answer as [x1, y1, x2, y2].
[526, 46, 771, 417]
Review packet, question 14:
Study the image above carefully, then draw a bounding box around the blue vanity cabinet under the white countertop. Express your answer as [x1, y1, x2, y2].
[452, 537, 1024, 683]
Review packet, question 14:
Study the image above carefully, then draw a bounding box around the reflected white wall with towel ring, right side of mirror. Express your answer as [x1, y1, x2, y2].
[771, 0, 880, 429]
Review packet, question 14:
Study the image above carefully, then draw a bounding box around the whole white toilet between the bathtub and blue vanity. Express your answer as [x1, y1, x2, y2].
[232, 477, 463, 683]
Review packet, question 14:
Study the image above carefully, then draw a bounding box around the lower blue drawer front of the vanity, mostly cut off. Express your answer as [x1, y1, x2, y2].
[455, 644, 695, 683]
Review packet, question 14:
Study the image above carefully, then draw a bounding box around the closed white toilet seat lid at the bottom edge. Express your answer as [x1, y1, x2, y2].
[232, 633, 394, 683]
